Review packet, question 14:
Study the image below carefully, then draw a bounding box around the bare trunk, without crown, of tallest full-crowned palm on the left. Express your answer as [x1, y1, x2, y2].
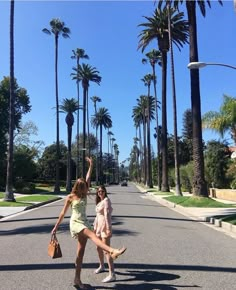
[54, 35, 60, 193]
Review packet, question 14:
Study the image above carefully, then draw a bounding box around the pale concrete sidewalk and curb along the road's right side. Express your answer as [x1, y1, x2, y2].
[136, 185, 236, 238]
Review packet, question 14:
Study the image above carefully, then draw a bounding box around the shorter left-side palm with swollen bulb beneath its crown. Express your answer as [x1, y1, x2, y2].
[59, 98, 79, 192]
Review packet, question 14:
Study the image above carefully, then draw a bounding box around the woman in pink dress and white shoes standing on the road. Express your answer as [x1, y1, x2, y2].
[94, 186, 116, 283]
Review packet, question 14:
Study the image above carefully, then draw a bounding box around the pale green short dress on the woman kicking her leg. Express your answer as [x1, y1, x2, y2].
[70, 198, 91, 239]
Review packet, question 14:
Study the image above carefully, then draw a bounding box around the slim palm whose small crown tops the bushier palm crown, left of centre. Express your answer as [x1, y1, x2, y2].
[71, 48, 89, 178]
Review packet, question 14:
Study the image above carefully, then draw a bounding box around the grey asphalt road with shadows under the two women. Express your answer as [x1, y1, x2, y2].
[0, 184, 236, 290]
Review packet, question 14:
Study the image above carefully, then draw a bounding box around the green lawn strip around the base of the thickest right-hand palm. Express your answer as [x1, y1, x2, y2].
[164, 196, 235, 208]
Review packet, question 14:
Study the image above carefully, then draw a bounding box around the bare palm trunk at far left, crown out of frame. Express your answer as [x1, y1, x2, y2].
[4, 0, 15, 201]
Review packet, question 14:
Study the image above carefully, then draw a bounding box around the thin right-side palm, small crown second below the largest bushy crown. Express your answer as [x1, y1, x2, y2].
[142, 74, 155, 188]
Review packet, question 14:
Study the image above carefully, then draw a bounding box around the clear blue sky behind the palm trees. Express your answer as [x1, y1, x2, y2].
[0, 0, 236, 162]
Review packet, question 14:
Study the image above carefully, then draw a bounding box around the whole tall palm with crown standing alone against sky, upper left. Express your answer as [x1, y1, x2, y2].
[42, 18, 70, 193]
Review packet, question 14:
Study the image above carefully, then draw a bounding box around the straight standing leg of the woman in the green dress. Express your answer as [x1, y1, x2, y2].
[74, 233, 87, 289]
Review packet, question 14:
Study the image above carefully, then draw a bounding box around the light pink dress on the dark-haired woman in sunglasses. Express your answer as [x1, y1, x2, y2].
[94, 197, 112, 238]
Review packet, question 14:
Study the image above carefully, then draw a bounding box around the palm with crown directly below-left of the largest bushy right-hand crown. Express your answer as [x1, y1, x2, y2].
[142, 49, 161, 190]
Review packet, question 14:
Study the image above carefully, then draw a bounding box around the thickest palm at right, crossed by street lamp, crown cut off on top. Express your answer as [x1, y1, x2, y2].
[159, 0, 222, 197]
